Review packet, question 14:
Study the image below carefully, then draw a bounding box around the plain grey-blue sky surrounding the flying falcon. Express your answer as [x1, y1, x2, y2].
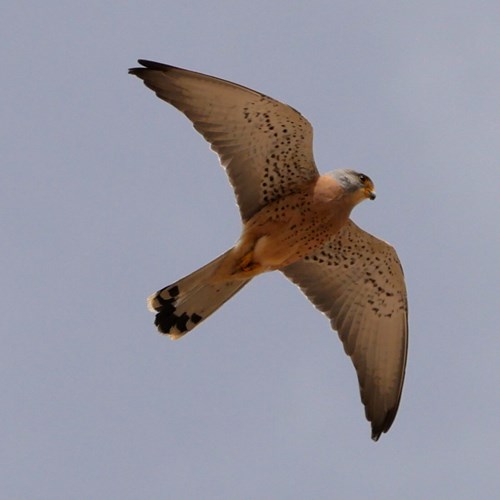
[0, 0, 500, 500]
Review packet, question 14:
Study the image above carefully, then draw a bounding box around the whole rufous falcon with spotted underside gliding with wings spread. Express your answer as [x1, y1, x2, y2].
[129, 59, 408, 441]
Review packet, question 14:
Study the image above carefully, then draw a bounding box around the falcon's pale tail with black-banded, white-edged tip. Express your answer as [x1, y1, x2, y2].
[148, 250, 251, 339]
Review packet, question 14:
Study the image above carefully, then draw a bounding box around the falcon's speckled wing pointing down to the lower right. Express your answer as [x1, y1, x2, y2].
[282, 221, 408, 440]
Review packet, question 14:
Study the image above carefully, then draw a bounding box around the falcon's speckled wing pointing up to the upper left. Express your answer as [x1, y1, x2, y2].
[129, 60, 319, 221]
